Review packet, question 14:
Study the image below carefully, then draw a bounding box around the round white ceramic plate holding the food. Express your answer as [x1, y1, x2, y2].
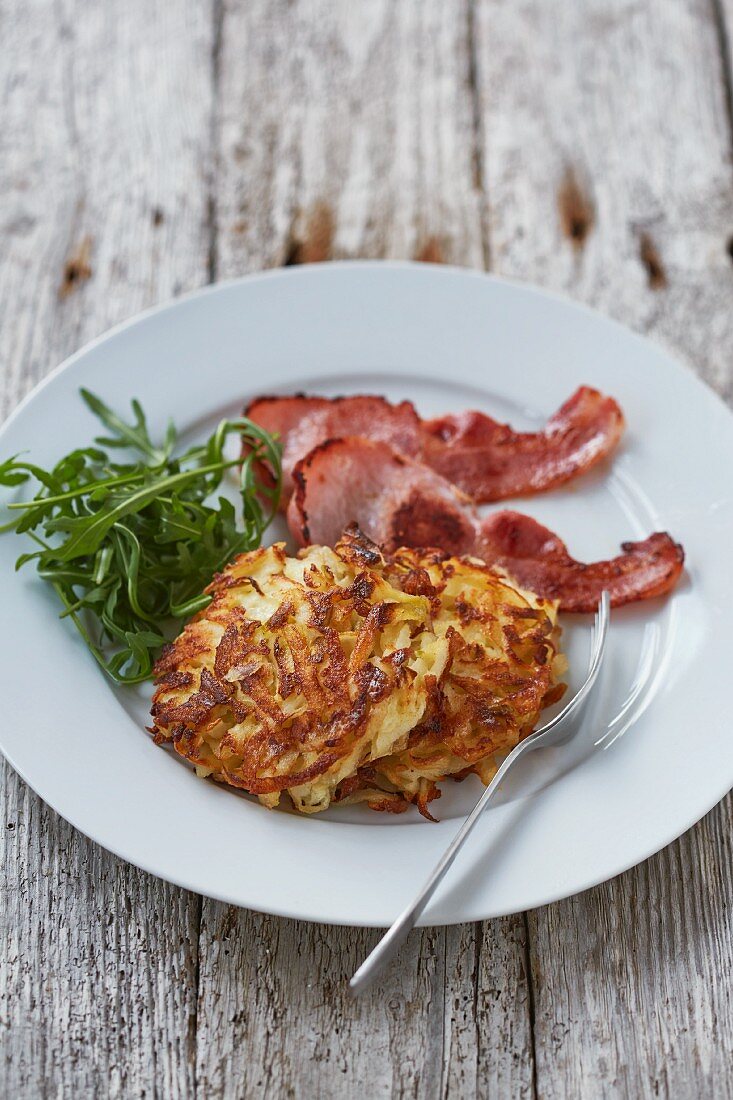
[0, 263, 733, 925]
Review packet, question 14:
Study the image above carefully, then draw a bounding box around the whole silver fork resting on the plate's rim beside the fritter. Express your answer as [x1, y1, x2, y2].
[349, 592, 611, 993]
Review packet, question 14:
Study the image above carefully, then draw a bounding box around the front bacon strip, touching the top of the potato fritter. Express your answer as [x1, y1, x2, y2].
[287, 438, 685, 612]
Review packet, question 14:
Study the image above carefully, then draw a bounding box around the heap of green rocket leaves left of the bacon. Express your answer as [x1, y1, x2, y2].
[0, 389, 282, 683]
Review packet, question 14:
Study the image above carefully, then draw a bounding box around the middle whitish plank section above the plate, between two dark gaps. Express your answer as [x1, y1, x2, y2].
[211, 0, 483, 276]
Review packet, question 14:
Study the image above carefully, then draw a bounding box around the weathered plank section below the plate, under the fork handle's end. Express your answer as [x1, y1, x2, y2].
[192, 901, 532, 1100]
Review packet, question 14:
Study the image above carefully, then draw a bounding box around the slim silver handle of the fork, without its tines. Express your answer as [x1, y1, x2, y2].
[349, 740, 532, 993]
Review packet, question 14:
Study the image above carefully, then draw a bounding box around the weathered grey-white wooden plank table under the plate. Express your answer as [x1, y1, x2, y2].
[0, 0, 733, 1100]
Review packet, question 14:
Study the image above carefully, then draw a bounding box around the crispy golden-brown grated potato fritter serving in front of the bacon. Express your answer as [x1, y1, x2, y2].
[151, 529, 564, 817]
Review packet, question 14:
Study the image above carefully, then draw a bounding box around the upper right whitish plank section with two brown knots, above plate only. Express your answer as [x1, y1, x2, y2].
[475, 0, 733, 397]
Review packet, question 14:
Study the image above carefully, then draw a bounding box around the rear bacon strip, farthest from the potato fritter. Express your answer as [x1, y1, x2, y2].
[244, 386, 624, 507]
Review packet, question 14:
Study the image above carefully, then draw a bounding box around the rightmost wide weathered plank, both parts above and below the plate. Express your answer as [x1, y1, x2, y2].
[475, 0, 733, 1098]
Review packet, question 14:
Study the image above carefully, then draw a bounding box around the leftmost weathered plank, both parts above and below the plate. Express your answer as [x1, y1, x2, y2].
[0, 0, 212, 1098]
